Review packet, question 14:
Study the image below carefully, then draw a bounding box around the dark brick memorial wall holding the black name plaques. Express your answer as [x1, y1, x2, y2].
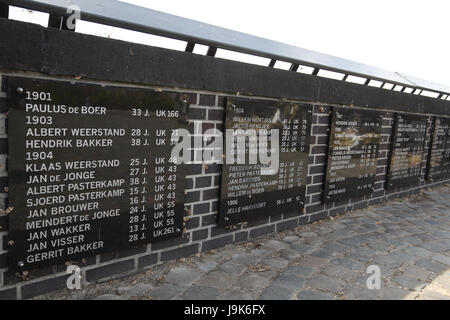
[0, 19, 450, 299]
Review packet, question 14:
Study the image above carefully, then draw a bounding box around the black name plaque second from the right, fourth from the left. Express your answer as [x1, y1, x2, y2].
[386, 113, 428, 189]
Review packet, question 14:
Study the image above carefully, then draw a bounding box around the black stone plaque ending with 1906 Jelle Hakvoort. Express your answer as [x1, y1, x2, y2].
[219, 98, 312, 227]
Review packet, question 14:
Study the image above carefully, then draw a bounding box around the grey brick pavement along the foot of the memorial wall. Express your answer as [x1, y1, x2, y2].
[35, 186, 450, 300]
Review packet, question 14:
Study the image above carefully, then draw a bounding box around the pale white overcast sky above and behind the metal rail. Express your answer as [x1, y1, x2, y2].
[7, 0, 450, 86]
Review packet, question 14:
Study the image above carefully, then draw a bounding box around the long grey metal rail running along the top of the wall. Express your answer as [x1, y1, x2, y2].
[0, 0, 450, 99]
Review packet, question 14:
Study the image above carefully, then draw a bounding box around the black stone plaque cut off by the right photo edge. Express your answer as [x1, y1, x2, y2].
[427, 117, 450, 181]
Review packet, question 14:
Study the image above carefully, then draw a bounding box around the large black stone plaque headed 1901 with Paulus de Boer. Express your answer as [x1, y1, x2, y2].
[6, 78, 189, 270]
